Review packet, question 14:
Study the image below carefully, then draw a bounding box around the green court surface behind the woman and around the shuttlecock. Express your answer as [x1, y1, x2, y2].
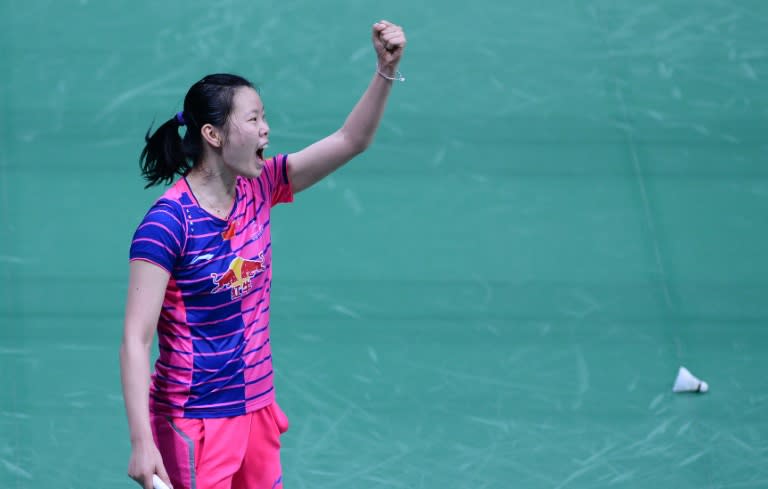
[0, 0, 768, 489]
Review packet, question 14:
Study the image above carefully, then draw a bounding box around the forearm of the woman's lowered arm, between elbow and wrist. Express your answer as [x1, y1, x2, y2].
[120, 339, 152, 445]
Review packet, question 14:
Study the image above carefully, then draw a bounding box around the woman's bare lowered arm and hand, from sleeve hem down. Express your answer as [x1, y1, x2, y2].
[120, 260, 170, 489]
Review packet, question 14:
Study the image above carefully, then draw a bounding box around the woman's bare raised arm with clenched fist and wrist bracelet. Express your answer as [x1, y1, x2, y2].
[288, 21, 406, 192]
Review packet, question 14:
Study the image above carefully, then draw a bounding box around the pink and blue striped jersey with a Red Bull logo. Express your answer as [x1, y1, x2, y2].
[130, 155, 293, 418]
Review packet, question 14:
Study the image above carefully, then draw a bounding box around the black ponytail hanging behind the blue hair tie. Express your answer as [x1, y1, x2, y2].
[139, 113, 192, 188]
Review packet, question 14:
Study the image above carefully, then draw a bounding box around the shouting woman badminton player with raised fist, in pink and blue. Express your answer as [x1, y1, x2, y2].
[120, 21, 406, 489]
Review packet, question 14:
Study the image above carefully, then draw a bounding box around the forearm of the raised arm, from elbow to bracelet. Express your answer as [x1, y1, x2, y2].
[340, 67, 392, 152]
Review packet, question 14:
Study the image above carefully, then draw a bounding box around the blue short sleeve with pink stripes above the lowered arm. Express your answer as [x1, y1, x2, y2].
[130, 199, 185, 273]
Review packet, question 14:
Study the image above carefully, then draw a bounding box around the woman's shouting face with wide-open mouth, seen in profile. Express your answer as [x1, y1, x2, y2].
[221, 87, 269, 178]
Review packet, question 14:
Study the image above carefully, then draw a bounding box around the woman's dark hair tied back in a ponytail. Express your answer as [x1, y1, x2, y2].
[139, 74, 253, 188]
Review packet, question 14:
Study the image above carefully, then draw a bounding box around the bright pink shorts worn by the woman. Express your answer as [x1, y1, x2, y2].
[150, 402, 288, 489]
